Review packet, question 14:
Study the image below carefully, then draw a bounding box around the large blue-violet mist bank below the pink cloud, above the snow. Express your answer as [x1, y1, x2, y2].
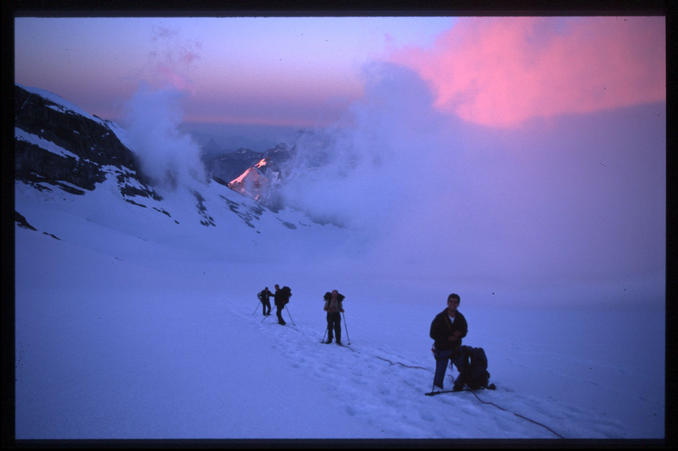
[274, 63, 666, 305]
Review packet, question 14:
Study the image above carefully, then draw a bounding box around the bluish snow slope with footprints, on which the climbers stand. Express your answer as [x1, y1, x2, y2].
[15, 178, 665, 439]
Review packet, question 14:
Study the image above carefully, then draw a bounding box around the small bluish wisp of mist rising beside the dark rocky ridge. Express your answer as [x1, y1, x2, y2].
[123, 83, 207, 189]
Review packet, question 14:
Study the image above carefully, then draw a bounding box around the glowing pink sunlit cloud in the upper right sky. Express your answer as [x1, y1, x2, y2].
[393, 17, 666, 127]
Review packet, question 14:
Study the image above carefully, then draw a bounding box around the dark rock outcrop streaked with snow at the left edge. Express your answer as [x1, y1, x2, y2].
[14, 86, 161, 205]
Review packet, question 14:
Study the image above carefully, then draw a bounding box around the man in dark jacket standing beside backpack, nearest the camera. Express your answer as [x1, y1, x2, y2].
[429, 293, 468, 390]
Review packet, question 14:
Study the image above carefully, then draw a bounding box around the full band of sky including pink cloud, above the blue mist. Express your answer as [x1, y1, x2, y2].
[15, 17, 666, 126]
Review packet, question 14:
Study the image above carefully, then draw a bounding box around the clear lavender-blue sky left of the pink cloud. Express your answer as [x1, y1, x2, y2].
[15, 17, 455, 126]
